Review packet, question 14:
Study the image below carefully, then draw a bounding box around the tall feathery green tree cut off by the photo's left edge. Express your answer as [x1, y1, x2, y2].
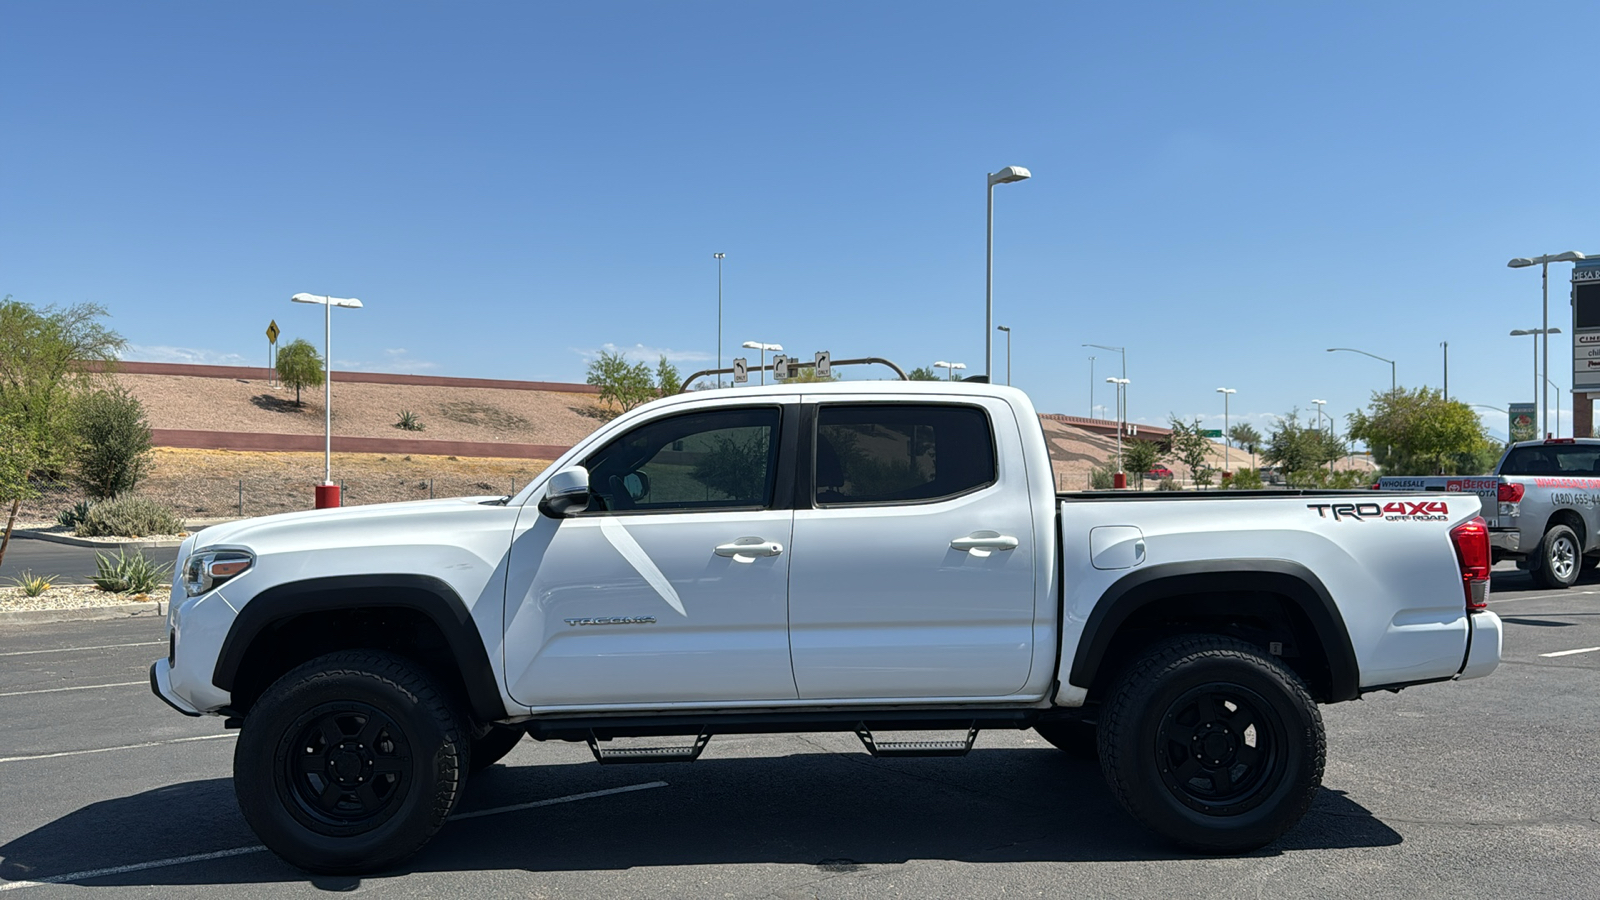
[0, 296, 125, 559]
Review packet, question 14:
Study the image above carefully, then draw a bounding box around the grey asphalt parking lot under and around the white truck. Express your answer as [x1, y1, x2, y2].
[0, 565, 1600, 898]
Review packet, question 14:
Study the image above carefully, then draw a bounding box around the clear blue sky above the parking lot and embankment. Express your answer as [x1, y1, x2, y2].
[0, 2, 1600, 432]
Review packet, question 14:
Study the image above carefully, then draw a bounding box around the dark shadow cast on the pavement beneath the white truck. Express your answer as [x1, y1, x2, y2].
[0, 741, 1402, 889]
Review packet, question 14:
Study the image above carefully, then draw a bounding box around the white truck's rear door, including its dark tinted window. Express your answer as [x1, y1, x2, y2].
[789, 396, 1038, 700]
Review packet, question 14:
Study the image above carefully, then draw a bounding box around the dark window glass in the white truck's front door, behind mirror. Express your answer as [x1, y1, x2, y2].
[584, 407, 779, 512]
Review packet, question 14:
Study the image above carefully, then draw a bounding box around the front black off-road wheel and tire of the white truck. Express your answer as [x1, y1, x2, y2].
[234, 650, 467, 874]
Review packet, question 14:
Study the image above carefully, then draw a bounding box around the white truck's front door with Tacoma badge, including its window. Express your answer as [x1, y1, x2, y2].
[504, 404, 795, 708]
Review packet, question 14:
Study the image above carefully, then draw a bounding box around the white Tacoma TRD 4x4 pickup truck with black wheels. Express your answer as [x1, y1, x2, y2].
[150, 383, 1501, 873]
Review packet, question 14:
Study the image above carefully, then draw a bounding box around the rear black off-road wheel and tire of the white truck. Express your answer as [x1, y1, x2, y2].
[1099, 634, 1326, 854]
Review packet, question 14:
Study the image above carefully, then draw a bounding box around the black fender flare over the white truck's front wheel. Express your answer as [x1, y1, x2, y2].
[211, 573, 506, 722]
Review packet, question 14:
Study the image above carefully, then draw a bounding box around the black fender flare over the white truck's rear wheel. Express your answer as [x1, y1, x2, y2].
[1067, 559, 1360, 703]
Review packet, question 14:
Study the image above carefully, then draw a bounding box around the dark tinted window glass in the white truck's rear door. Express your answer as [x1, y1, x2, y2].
[816, 404, 995, 506]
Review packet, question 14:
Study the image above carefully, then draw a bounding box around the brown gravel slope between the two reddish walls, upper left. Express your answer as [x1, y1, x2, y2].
[117, 375, 611, 447]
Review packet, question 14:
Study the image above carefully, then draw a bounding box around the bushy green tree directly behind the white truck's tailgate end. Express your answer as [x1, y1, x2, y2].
[1349, 388, 1494, 476]
